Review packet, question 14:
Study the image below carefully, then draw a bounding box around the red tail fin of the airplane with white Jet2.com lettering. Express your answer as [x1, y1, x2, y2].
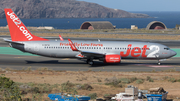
[4, 8, 48, 41]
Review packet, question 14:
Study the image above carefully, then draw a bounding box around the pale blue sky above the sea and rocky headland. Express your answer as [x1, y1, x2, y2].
[77, 0, 180, 11]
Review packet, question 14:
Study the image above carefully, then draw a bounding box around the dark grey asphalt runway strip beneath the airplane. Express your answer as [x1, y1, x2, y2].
[0, 39, 180, 72]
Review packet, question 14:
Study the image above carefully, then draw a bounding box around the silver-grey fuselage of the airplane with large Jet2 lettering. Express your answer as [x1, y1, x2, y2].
[10, 40, 176, 59]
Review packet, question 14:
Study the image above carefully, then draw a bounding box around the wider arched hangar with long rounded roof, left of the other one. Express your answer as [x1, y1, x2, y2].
[80, 21, 115, 30]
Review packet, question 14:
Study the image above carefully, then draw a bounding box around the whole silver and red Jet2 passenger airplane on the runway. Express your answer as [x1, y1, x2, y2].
[4, 8, 177, 65]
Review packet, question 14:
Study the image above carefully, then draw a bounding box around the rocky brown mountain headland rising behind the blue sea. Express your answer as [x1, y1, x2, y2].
[0, 0, 149, 19]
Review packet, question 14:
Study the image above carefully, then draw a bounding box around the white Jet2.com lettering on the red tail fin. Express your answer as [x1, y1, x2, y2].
[7, 12, 33, 40]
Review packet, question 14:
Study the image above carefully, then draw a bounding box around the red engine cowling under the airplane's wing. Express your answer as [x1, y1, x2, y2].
[104, 54, 121, 63]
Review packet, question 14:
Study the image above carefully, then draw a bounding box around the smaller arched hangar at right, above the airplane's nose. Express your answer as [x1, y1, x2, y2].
[146, 21, 167, 30]
